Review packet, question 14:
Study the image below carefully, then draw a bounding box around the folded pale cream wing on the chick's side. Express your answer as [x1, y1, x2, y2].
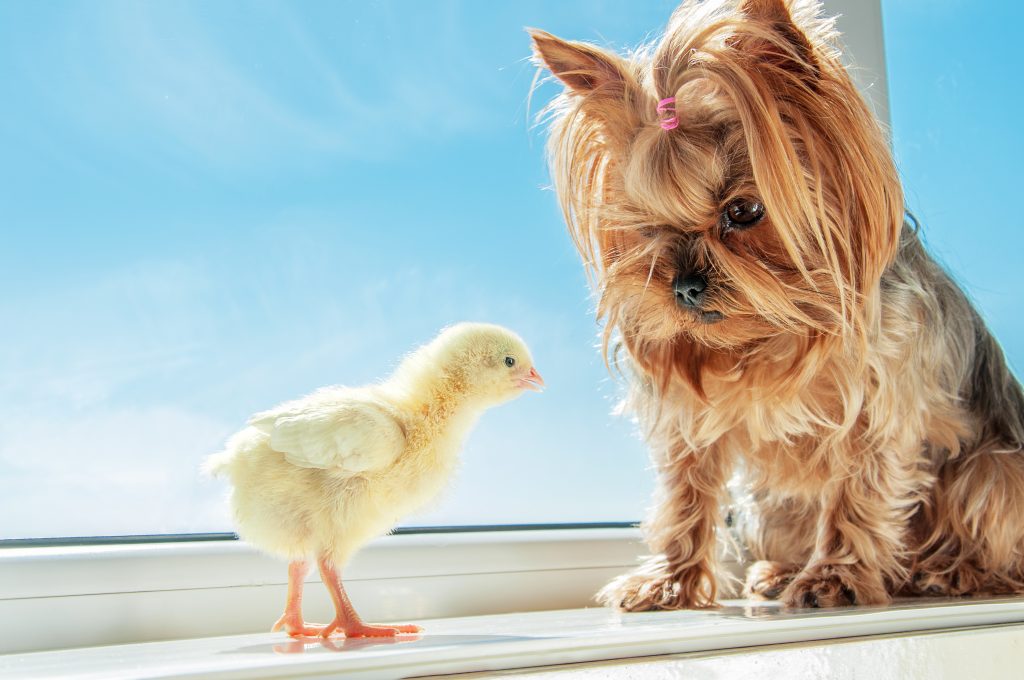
[249, 396, 406, 473]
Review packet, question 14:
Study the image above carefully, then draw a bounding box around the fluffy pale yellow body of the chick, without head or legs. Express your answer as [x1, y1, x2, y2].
[208, 388, 479, 564]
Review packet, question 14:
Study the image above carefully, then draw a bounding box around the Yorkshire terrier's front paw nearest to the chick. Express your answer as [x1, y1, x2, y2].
[597, 560, 717, 611]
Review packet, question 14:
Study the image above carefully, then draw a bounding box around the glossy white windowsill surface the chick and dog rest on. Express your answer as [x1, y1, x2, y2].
[6, 599, 1024, 678]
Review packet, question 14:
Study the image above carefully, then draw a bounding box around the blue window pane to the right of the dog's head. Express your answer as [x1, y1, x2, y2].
[882, 0, 1024, 375]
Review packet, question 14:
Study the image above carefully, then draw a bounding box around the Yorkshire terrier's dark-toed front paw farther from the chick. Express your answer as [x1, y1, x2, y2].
[781, 565, 892, 607]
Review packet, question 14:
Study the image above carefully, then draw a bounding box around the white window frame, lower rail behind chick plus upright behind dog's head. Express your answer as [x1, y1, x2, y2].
[0, 0, 889, 653]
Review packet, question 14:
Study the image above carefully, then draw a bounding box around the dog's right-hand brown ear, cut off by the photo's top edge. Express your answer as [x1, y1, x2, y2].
[732, 0, 819, 78]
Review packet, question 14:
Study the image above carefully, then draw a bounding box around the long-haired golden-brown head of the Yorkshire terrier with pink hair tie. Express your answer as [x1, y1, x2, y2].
[531, 0, 903, 391]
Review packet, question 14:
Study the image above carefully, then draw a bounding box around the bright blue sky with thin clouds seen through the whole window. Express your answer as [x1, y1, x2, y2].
[0, 0, 1024, 538]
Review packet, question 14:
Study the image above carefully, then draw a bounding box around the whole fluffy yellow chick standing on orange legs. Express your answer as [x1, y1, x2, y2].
[204, 323, 544, 637]
